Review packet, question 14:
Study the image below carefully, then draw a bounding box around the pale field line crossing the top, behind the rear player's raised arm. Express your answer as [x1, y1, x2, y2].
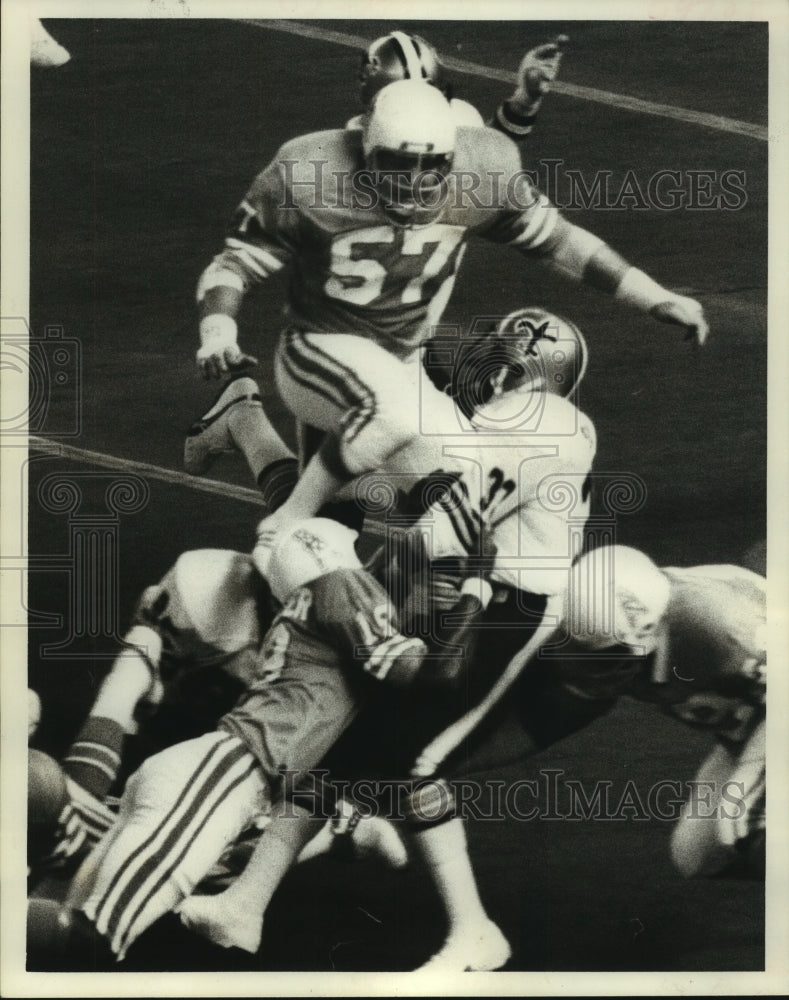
[245, 18, 768, 142]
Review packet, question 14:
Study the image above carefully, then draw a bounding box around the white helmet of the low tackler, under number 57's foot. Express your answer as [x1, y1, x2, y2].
[266, 517, 362, 604]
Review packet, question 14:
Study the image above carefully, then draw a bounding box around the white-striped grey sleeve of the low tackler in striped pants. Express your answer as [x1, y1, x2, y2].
[315, 570, 427, 687]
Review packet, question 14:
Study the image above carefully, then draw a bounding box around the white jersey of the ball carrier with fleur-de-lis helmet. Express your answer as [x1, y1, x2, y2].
[366, 392, 597, 594]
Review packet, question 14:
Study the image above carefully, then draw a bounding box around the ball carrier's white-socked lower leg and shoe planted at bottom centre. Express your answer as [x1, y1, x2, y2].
[413, 818, 511, 972]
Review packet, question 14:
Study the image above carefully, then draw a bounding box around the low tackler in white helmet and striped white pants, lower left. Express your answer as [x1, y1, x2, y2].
[32, 520, 498, 959]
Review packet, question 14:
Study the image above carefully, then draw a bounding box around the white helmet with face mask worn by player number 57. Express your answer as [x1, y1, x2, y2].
[362, 80, 455, 226]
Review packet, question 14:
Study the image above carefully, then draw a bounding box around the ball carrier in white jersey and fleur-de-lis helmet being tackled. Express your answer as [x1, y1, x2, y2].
[181, 330, 594, 970]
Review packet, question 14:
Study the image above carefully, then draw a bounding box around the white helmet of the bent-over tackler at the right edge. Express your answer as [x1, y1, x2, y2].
[565, 545, 671, 656]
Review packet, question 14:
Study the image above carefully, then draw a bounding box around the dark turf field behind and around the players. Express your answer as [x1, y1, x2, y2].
[24, 20, 767, 971]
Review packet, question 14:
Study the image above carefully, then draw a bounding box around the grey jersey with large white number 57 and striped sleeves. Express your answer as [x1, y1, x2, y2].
[203, 127, 559, 358]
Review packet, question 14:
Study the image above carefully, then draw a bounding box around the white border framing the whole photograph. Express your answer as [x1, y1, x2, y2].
[0, 0, 789, 997]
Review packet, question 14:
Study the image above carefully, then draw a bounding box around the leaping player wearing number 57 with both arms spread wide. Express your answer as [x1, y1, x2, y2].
[192, 80, 707, 560]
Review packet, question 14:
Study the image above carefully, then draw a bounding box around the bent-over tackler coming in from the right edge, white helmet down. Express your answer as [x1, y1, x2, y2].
[412, 546, 766, 877]
